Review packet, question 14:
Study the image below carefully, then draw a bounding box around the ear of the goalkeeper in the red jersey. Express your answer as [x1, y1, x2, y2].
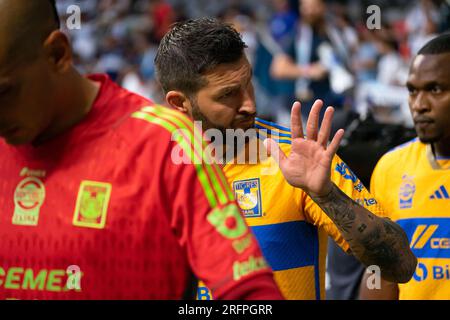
[44, 30, 72, 73]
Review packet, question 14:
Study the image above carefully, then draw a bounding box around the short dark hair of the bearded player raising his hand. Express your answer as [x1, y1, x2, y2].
[155, 18, 247, 97]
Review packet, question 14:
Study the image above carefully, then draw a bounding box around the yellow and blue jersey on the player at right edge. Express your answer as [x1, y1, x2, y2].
[371, 138, 450, 300]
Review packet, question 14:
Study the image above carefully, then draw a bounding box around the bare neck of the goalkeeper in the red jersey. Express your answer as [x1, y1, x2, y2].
[33, 70, 100, 145]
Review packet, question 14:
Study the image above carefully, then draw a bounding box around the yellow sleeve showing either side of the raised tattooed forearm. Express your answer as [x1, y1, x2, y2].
[302, 155, 386, 252]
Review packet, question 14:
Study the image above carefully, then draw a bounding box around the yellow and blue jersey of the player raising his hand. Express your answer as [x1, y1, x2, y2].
[198, 119, 384, 300]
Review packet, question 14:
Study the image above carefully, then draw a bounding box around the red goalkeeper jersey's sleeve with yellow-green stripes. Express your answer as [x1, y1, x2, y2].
[158, 109, 282, 299]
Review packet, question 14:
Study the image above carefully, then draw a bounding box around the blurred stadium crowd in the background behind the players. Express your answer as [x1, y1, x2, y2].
[57, 0, 450, 299]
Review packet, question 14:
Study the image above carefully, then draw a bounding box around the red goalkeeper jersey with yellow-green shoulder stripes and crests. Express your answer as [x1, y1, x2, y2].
[0, 75, 280, 299]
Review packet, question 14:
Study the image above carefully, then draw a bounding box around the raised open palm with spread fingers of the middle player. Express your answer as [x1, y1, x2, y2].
[265, 100, 344, 197]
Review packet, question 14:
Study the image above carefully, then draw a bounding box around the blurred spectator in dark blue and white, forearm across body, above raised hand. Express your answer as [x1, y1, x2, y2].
[272, 0, 351, 124]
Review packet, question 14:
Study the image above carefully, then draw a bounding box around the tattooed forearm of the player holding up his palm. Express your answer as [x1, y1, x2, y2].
[312, 184, 417, 283]
